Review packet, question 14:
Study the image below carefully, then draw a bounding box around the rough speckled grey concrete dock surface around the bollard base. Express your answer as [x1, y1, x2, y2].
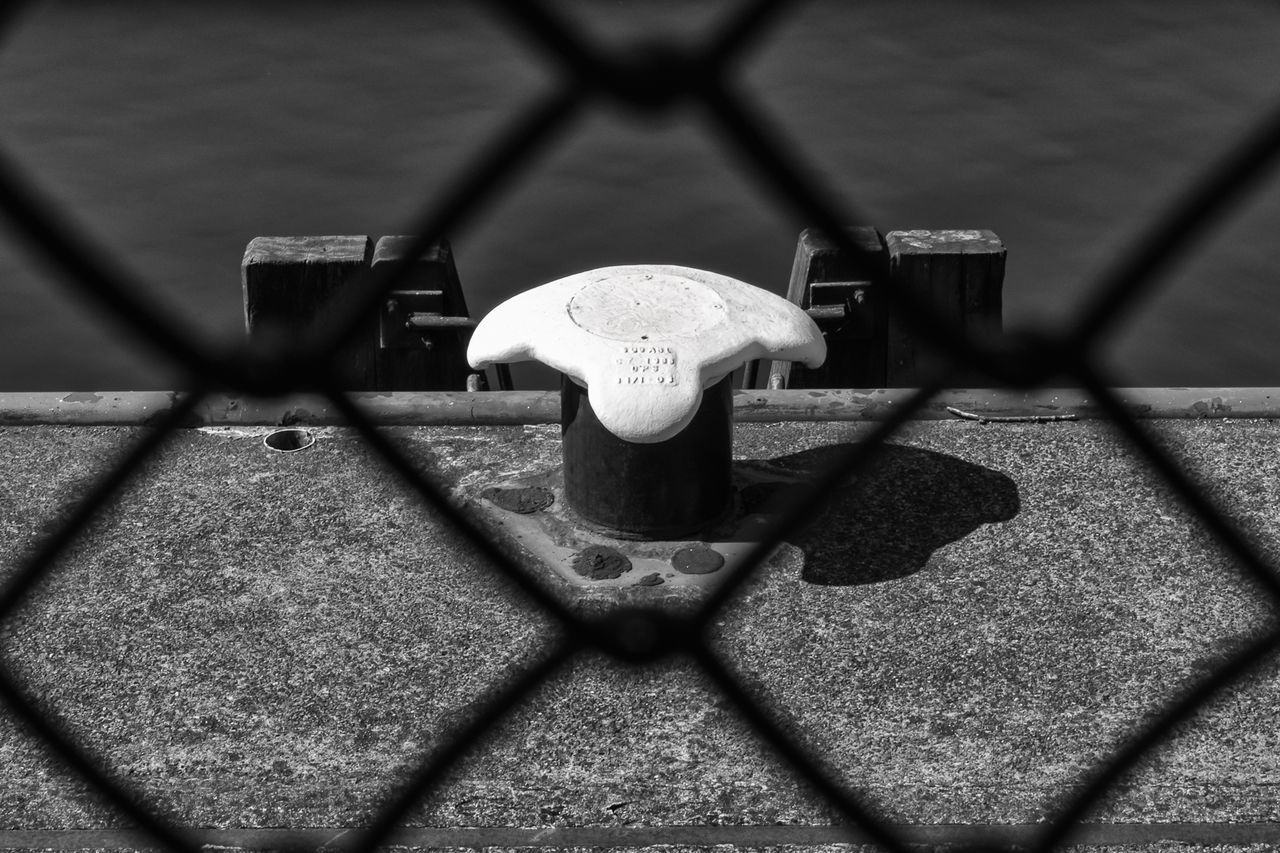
[0, 419, 1280, 850]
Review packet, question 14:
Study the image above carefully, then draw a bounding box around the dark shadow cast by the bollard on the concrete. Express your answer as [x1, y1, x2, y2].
[740, 444, 1020, 587]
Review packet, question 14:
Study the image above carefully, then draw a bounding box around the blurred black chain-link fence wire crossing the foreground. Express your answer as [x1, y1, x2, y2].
[0, 0, 1280, 850]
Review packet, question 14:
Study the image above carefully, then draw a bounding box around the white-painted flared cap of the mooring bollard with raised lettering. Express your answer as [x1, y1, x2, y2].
[467, 264, 827, 443]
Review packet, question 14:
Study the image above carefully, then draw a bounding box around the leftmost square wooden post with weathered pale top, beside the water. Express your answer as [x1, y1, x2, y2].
[241, 236, 378, 391]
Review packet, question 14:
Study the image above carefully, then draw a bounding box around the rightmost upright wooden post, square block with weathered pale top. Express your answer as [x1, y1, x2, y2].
[884, 231, 1005, 388]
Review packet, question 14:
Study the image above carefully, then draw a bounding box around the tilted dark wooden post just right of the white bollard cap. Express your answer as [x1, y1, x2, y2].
[768, 225, 888, 388]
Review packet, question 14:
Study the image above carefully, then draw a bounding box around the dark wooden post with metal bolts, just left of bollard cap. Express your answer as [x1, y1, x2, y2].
[372, 237, 471, 391]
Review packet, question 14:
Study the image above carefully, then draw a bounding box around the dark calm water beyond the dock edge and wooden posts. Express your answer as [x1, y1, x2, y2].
[0, 0, 1280, 391]
